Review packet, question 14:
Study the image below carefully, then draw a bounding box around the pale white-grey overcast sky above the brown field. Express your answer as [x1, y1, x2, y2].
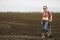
[0, 0, 60, 12]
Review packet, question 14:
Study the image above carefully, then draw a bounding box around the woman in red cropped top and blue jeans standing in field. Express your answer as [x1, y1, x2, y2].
[42, 6, 52, 38]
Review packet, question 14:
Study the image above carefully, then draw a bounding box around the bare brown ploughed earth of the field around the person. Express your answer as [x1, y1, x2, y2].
[0, 13, 60, 40]
